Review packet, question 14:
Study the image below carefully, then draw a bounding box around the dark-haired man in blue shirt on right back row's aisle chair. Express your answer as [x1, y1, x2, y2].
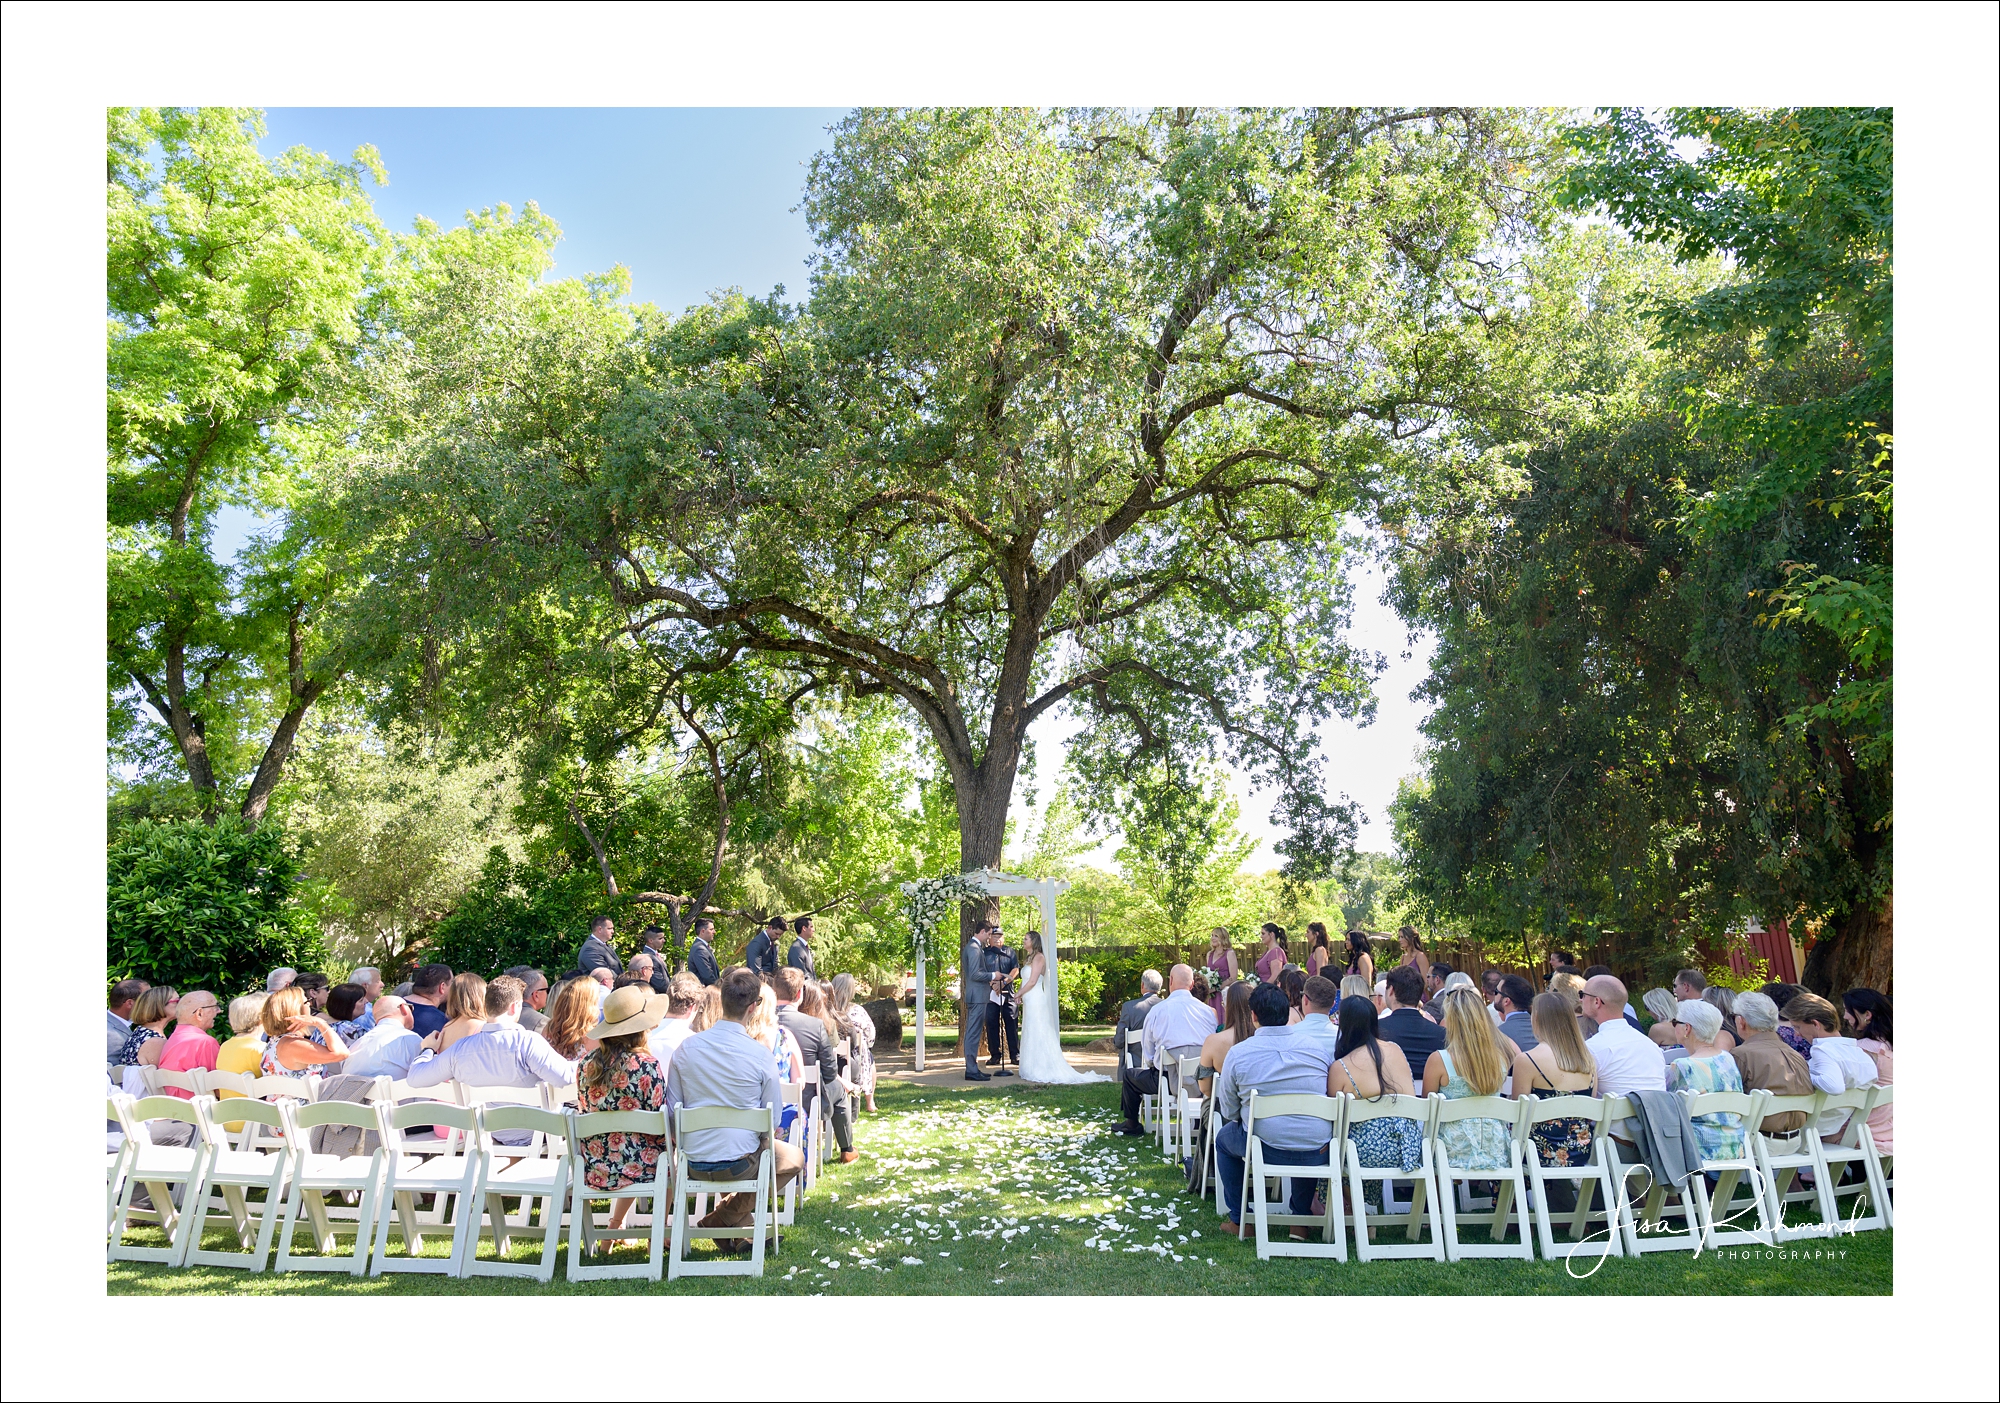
[1208, 983, 1336, 1237]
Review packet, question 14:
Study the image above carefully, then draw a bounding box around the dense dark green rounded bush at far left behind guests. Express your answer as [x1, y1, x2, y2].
[106, 817, 328, 1001]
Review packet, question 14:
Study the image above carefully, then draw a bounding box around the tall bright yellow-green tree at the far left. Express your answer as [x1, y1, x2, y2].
[106, 108, 386, 821]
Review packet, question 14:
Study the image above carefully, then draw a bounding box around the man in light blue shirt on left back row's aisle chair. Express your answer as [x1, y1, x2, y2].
[666, 967, 806, 1227]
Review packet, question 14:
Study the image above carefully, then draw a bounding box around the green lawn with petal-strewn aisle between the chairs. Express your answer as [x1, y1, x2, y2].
[108, 1083, 1894, 1295]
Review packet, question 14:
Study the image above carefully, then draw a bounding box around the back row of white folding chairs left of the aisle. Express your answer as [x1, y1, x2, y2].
[106, 1077, 790, 1281]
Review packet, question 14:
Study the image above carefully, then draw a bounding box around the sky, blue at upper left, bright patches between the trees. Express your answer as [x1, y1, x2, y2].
[250, 108, 1430, 869]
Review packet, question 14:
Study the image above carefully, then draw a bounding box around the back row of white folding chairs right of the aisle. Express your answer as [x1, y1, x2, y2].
[1154, 1079, 1896, 1261]
